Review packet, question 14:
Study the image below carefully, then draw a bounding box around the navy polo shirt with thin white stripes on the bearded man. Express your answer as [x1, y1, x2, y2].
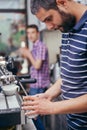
[61, 11, 87, 130]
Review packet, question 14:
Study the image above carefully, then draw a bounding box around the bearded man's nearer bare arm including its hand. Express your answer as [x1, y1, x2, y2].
[22, 94, 87, 115]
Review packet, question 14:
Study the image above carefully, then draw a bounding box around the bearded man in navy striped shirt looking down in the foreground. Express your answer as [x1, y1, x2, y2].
[23, 0, 87, 130]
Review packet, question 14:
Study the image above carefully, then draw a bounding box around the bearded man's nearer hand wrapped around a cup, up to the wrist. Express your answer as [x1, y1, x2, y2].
[22, 94, 53, 115]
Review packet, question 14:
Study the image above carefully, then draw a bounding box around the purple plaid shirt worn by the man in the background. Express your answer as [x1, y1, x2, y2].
[30, 40, 50, 88]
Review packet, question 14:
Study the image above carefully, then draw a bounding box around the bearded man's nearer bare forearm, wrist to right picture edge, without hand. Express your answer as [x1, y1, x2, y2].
[52, 94, 87, 114]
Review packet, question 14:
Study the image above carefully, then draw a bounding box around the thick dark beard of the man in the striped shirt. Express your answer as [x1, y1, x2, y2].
[58, 10, 76, 33]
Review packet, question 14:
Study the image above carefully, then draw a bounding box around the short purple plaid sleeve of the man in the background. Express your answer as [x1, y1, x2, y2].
[36, 45, 47, 60]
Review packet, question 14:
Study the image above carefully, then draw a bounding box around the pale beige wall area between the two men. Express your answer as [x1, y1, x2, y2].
[43, 31, 62, 64]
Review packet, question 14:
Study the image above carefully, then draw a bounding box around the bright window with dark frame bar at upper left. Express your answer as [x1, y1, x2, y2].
[0, 0, 27, 55]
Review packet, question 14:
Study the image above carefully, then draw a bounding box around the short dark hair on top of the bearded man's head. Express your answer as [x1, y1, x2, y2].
[31, 0, 58, 14]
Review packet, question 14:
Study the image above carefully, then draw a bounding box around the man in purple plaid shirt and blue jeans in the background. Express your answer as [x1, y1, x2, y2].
[20, 24, 50, 130]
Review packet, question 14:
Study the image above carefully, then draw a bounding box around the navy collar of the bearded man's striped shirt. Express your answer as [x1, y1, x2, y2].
[73, 11, 87, 31]
